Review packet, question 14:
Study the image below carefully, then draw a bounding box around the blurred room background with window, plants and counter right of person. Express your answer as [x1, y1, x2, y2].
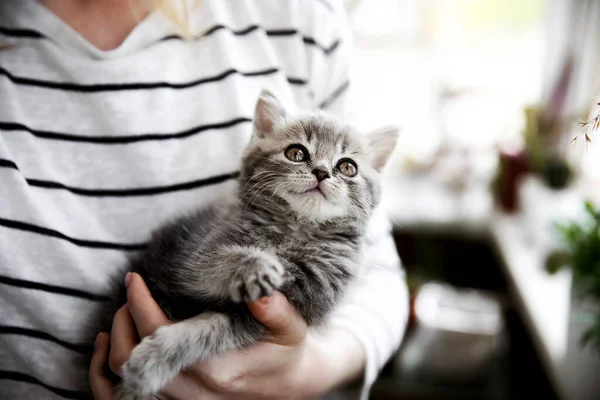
[346, 0, 600, 400]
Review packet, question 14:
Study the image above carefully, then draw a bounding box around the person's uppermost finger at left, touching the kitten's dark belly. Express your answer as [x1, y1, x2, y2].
[126, 273, 171, 338]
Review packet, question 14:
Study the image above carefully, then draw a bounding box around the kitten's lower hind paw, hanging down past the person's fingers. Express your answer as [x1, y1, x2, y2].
[123, 325, 182, 398]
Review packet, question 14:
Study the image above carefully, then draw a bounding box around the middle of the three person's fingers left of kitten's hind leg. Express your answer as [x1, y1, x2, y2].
[108, 305, 138, 376]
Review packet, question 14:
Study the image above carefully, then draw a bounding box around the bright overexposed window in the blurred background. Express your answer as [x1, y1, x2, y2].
[351, 0, 544, 162]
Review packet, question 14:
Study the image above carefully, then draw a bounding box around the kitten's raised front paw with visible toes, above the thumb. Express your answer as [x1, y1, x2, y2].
[229, 252, 285, 302]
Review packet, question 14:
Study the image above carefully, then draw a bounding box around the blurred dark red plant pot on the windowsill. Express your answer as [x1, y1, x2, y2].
[493, 151, 529, 212]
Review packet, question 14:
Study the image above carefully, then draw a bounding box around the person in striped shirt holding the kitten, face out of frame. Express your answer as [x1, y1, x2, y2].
[0, 0, 408, 400]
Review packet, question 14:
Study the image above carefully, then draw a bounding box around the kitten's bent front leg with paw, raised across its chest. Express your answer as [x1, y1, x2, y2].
[183, 246, 287, 303]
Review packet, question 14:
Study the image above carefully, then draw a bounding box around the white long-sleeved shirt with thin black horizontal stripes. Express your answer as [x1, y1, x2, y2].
[0, 0, 407, 400]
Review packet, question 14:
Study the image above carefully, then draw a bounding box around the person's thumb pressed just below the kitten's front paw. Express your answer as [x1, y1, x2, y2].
[248, 291, 307, 346]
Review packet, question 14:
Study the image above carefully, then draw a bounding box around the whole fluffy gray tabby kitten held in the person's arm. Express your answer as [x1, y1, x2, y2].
[117, 91, 397, 399]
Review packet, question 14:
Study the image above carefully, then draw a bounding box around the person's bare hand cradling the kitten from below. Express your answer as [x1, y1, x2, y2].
[90, 274, 364, 400]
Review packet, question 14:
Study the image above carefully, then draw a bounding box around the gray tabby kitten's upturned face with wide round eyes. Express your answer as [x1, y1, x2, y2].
[242, 89, 395, 221]
